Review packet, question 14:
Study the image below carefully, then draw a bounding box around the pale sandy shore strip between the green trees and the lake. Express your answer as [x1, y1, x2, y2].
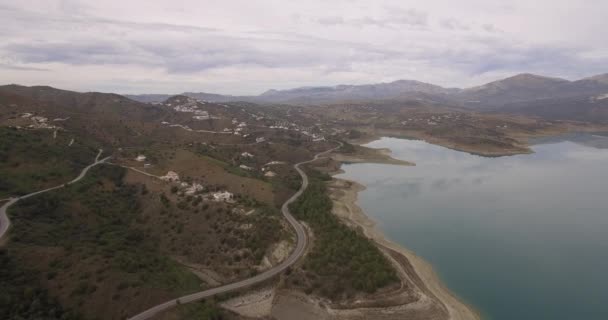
[330, 178, 480, 320]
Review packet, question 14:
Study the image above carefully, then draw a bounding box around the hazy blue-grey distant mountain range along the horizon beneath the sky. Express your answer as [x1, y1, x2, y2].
[127, 73, 608, 121]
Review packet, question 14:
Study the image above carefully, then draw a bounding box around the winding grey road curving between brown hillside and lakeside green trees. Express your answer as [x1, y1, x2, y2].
[128, 142, 342, 320]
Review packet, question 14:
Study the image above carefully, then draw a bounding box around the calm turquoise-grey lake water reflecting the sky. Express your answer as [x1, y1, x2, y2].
[341, 136, 608, 320]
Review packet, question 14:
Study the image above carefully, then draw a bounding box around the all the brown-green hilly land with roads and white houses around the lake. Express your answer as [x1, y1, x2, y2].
[0, 80, 608, 319]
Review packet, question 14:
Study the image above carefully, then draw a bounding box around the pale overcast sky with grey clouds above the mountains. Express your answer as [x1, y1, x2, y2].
[0, 0, 608, 94]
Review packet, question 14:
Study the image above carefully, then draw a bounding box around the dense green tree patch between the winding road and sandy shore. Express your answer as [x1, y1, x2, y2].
[291, 174, 398, 299]
